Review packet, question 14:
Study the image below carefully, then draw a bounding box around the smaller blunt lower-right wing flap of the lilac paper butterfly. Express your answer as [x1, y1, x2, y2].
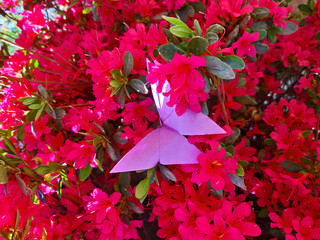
[160, 126, 201, 165]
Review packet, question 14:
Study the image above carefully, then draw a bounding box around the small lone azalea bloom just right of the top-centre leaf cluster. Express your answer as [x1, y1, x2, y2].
[232, 31, 259, 57]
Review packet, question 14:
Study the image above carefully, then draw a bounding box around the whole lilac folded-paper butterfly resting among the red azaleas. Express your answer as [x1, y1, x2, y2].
[110, 70, 225, 173]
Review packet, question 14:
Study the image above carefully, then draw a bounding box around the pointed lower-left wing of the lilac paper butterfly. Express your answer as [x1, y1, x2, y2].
[110, 128, 160, 173]
